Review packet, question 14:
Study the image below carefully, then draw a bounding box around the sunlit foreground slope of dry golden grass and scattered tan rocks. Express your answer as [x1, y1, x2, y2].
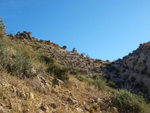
[0, 73, 115, 113]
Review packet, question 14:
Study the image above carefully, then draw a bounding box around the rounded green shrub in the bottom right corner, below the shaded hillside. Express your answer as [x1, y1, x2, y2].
[114, 90, 150, 113]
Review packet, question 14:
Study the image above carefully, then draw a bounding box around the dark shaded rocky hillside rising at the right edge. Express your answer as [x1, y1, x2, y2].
[106, 42, 150, 97]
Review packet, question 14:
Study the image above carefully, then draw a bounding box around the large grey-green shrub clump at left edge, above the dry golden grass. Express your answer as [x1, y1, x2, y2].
[0, 48, 32, 77]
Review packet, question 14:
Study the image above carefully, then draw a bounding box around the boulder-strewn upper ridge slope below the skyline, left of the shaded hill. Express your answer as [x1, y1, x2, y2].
[9, 31, 108, 76]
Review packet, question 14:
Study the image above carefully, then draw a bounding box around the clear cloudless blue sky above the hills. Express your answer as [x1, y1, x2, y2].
[0, 0, 150, 61]
